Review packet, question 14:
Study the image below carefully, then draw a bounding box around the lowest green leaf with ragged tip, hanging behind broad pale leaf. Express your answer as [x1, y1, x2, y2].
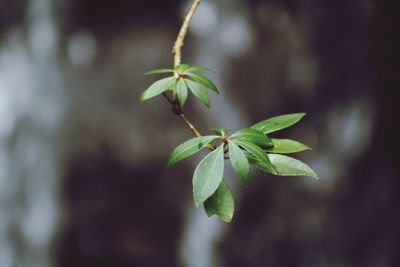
[204, 180, 235, 223]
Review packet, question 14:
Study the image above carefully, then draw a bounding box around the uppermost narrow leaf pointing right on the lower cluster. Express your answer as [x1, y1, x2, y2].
[251, 113, 306, 134]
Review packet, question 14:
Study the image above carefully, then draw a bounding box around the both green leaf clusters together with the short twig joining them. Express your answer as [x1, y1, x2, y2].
[141, 61, 318, 222]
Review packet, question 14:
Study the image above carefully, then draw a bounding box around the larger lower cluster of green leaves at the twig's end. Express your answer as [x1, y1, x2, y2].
[167, 113, 318, 222]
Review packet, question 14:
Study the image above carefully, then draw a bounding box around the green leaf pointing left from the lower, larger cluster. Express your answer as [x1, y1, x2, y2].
[167, 135, 218, 167]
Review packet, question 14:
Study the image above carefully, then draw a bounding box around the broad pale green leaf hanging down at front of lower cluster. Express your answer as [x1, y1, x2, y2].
[193, 145, 224, 207]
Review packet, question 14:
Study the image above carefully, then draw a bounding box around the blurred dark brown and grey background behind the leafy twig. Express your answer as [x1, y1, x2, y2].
[0, 0, 400, 267]
